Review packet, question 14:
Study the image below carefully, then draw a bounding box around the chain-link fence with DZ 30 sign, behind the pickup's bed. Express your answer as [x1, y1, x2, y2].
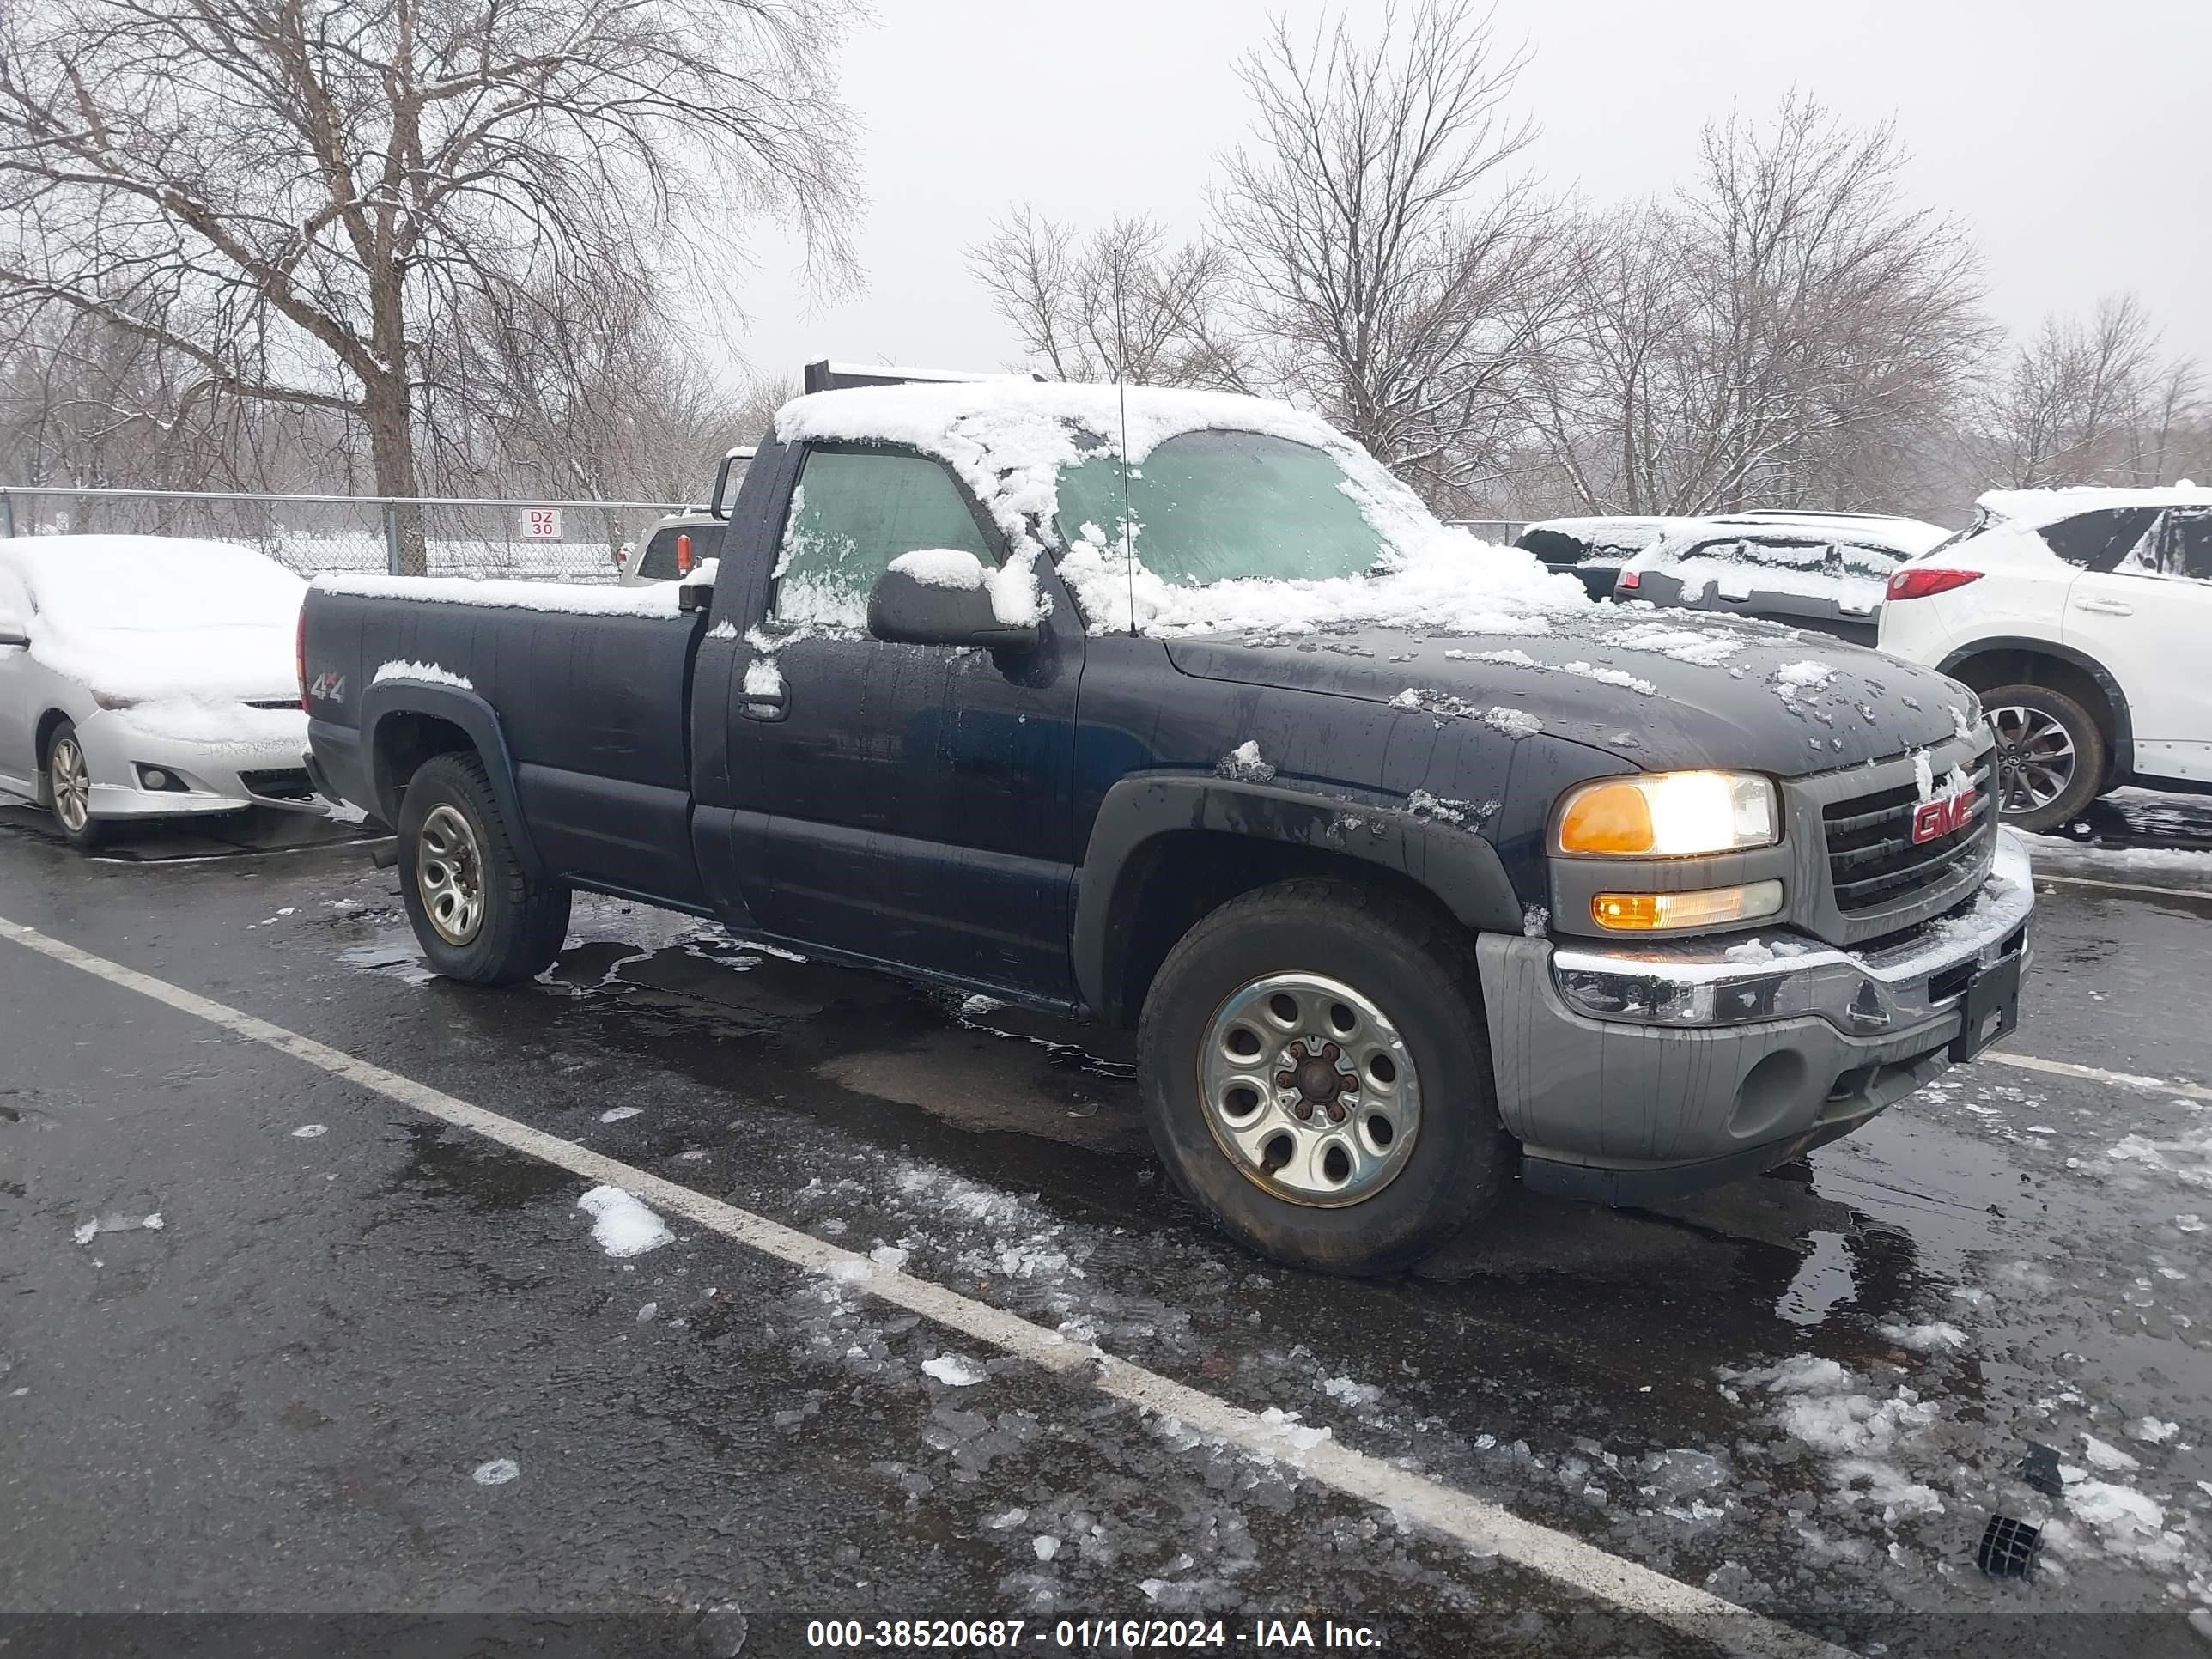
[0, 484, 681, 581]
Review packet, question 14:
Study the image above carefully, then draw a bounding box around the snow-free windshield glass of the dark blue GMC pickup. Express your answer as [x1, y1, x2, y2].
[1060, 431, 1387, 588]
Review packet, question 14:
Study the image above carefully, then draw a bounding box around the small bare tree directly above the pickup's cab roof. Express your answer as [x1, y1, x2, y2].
[969, 206, 1248, 389]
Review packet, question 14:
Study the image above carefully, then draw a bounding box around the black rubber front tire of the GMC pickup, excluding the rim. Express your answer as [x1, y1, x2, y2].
[1137, 880, 1513, 1274]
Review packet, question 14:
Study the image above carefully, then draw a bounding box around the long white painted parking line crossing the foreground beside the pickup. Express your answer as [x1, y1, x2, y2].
[0, 918, 1850, 1659]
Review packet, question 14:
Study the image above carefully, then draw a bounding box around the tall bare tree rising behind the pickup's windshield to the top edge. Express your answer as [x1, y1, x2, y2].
[1214, 0, 1573, 504]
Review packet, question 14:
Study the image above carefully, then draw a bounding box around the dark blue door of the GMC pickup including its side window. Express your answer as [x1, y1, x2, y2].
[728, 445, 1084, 998]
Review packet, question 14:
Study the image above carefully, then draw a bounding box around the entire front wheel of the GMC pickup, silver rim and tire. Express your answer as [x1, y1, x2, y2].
[1137, 880, 1513, 1274]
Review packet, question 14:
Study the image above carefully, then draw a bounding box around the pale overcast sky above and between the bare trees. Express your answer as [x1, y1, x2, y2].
[732, 0, 2212, 374]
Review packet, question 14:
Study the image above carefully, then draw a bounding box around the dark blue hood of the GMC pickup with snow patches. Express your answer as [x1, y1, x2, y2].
[1166, 606, 1978, 776]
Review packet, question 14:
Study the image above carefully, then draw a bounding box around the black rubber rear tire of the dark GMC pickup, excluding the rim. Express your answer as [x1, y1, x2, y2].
[398, 754, 568, 984]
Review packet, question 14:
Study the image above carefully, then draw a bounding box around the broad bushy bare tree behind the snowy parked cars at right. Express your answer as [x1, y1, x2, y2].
[1544, 95, 1993, 514]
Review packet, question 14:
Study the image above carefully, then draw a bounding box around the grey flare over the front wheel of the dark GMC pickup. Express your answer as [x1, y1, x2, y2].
[1073, 772, 1522, 1018]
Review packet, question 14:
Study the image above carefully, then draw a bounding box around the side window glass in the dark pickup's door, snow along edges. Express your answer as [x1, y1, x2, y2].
[768, 445, 995, 629]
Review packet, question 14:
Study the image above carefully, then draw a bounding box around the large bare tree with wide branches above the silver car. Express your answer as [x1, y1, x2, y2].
[0, 0, 852, 564]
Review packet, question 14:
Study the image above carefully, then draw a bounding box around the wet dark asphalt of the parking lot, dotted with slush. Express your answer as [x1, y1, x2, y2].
[0, 796, 2212, 1659]
